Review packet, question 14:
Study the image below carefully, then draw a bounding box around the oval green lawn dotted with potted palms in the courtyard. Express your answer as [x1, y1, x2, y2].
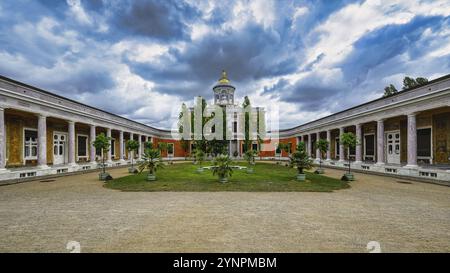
[105, 162, 350, 192]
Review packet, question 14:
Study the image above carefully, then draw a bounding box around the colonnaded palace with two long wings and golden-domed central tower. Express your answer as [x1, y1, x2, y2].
[0, 73, 450, 183]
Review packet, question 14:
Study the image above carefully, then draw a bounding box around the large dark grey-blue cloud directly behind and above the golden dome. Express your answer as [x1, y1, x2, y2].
[128, 24, 297, 97]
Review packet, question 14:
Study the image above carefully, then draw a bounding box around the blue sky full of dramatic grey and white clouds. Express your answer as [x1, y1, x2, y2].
[0, 0, 450, 128]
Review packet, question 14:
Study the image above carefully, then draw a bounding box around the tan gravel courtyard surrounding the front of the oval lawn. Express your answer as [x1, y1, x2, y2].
[0, 169, 450, 252]
